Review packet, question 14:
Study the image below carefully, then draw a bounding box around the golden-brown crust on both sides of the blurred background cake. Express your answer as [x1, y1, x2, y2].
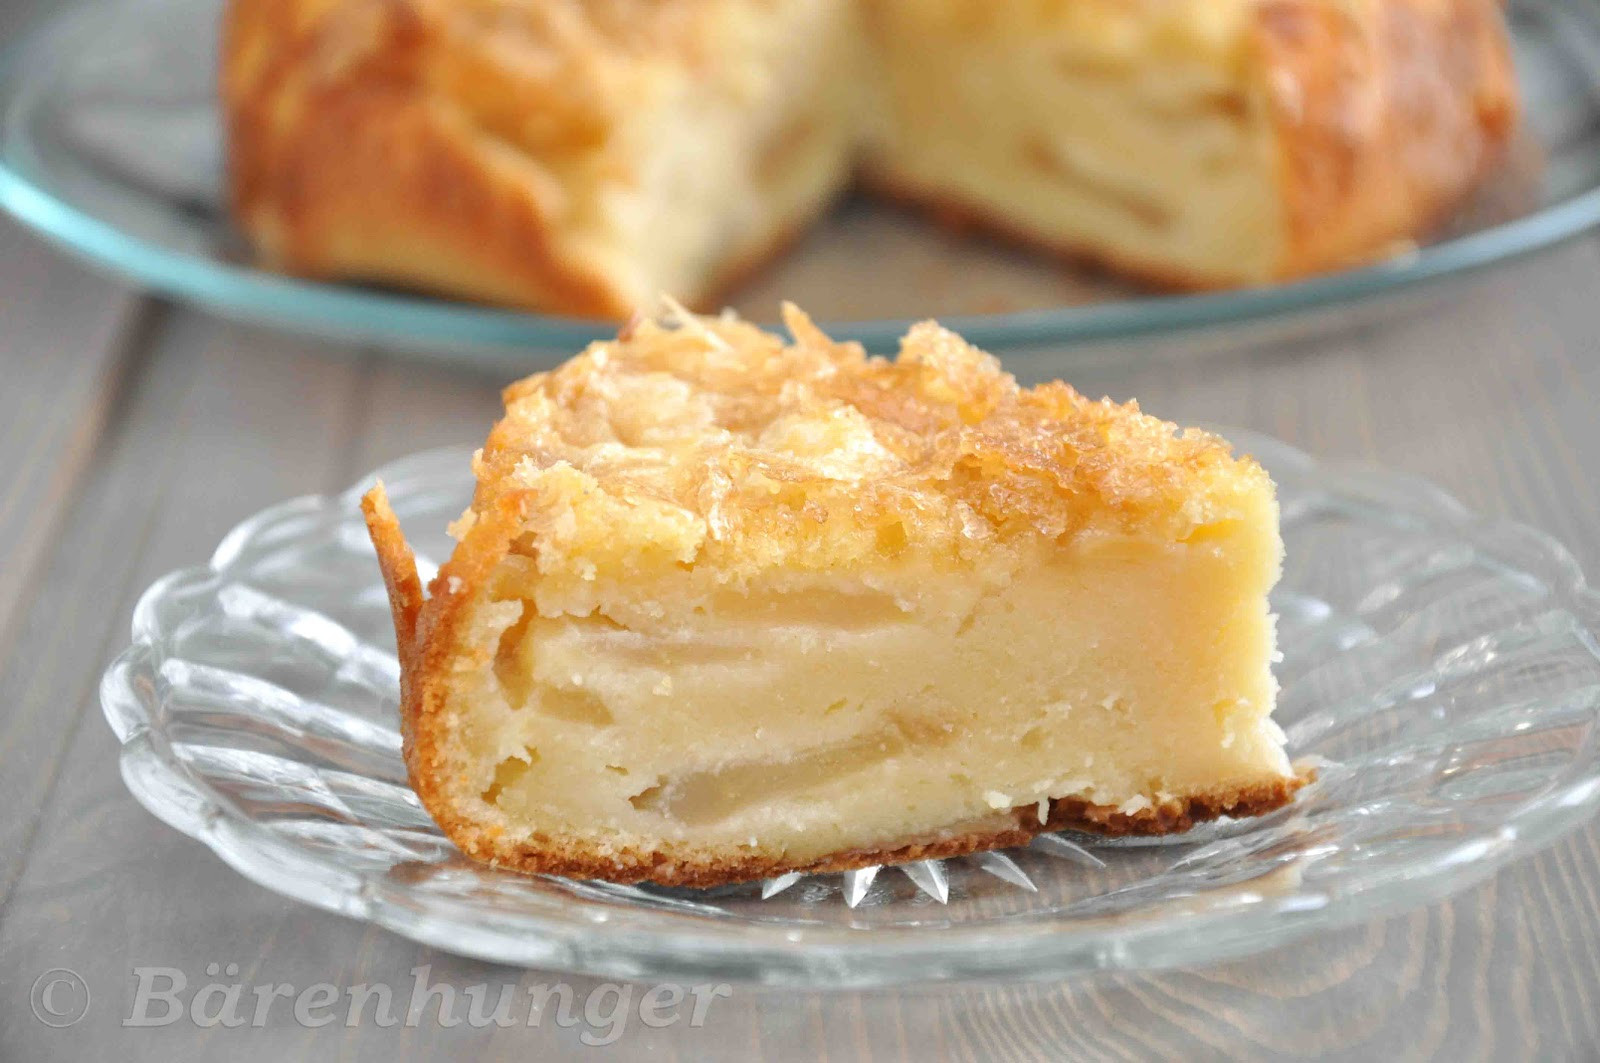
[222, 0, 1515, 319]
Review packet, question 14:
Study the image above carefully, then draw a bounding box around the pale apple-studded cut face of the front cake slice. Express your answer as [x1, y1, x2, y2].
[453, 522, 1290, 863]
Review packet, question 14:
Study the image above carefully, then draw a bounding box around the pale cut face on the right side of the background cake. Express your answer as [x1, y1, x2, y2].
[867, 0, 1286, 283]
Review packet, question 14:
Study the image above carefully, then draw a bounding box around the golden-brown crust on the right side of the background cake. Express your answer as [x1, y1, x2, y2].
[1251, 0, 1517, 277]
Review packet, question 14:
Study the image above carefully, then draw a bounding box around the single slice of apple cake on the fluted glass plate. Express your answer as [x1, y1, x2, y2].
[365, 307, 1299, 885]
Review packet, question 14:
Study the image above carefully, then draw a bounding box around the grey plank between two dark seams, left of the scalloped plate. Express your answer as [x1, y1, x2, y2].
[0, 308, 355, 922]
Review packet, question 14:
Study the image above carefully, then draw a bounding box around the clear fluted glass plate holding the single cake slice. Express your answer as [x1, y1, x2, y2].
[101, 432, 1600, 986]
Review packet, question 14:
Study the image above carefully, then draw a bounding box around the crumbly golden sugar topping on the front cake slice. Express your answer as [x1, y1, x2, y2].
[454, 306, 1272, 580]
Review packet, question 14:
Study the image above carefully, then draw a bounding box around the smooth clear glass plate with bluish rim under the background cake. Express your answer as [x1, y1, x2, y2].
[0, 0, 1600, 367]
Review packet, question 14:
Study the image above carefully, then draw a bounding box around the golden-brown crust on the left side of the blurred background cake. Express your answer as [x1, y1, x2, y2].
[222, 0, 632, 319]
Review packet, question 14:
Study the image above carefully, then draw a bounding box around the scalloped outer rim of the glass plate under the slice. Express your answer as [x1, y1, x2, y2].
[101, 429, 1600, 988]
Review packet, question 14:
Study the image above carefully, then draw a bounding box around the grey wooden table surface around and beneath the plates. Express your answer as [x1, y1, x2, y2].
[0, 188, 1600, 1063]
